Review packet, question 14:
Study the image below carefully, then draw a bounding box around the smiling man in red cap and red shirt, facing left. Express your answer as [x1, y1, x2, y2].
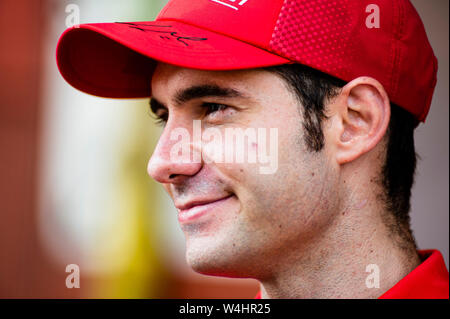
[57, 0, 448, 298]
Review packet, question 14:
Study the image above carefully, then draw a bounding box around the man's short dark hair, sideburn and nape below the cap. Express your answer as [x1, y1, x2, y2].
[265, 64, 418, 247]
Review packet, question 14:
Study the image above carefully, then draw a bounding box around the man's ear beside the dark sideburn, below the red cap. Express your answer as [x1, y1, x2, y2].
[328, 77, 391, 164]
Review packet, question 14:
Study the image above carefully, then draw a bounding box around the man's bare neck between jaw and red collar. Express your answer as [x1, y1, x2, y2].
[260, 205, 420, 299]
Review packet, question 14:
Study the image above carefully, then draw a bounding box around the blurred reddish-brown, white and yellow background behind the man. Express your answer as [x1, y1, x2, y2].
[0, 0, 449, 298]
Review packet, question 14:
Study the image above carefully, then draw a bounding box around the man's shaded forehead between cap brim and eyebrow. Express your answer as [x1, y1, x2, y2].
[151, 62, 288, 99]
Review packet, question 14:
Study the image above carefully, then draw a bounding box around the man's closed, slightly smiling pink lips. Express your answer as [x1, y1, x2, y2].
[175, 194, 234, 223]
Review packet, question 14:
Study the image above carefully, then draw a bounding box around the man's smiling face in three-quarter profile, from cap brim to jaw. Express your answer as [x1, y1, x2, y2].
[148, 64, 337, 278]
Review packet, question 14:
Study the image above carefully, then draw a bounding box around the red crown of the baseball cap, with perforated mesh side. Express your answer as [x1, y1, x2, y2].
[157, 0, 437, 121]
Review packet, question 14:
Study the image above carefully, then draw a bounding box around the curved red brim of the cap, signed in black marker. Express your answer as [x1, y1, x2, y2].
[56, 21, 291, 98]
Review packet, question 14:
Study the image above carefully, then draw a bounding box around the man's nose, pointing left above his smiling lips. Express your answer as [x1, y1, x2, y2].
[147, 123, 202, 184]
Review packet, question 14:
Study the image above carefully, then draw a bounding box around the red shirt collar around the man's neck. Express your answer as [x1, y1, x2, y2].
[255, 249, 449, 299]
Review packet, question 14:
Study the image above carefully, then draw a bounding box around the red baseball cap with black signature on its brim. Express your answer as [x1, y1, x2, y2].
[56, 0, 437, 121]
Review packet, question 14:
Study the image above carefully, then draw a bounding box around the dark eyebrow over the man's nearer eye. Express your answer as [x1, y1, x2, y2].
[174, 84, 248, 105]
